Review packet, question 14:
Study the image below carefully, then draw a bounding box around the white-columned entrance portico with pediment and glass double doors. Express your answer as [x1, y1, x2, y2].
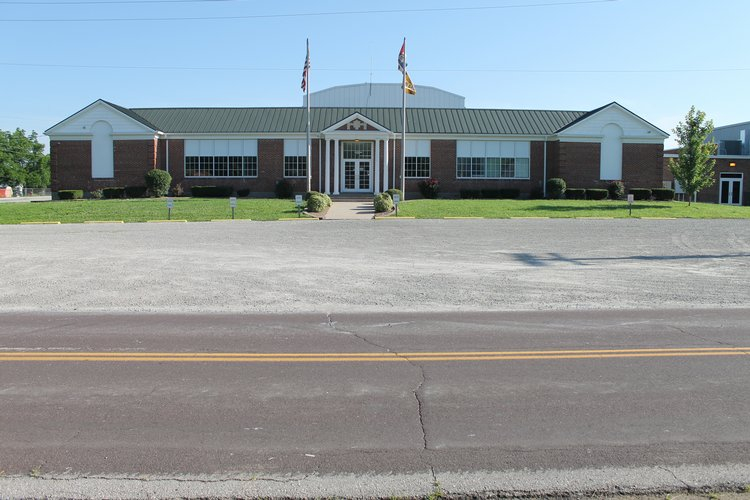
[321, 113, 393, 195]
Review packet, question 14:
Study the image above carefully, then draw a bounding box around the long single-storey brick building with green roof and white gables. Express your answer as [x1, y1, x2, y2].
[45, 86, 667, 196]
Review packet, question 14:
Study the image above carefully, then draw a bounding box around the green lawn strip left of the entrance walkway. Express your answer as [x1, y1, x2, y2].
[0, 198, 306, 224]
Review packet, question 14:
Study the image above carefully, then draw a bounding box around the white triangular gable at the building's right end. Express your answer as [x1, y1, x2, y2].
[557, 103, 668, 143]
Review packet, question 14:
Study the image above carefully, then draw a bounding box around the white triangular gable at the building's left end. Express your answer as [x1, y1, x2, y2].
[45, 100, 156, 140]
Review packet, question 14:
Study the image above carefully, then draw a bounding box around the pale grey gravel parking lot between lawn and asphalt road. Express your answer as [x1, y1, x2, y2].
[0, 219, 750, 313]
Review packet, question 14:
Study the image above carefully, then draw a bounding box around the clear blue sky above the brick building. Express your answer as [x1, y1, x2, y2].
[0, 0, 750, 145]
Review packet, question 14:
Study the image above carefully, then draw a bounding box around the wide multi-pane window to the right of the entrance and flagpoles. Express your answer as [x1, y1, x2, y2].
[456, 141, 531, 179]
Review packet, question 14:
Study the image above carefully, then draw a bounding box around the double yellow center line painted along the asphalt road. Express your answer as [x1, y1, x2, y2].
[0, 347, 750, 363]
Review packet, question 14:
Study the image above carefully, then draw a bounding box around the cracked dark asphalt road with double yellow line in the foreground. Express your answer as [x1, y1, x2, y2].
[0, 309, 750, 496]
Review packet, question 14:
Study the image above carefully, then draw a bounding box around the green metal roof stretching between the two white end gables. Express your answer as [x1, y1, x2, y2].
[129, 108, 587, 135]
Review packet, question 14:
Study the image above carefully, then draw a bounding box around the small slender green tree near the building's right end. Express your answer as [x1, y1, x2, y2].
[669, 106, 716, 206]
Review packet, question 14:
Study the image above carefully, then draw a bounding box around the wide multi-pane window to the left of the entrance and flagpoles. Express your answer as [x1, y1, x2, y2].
[185, 139, 258, 177]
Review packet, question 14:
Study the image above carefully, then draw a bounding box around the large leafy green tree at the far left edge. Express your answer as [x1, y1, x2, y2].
[0, 129, 50, 188]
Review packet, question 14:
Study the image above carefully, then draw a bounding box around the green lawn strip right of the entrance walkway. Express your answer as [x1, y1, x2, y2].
[399, 200, 750, 219]
